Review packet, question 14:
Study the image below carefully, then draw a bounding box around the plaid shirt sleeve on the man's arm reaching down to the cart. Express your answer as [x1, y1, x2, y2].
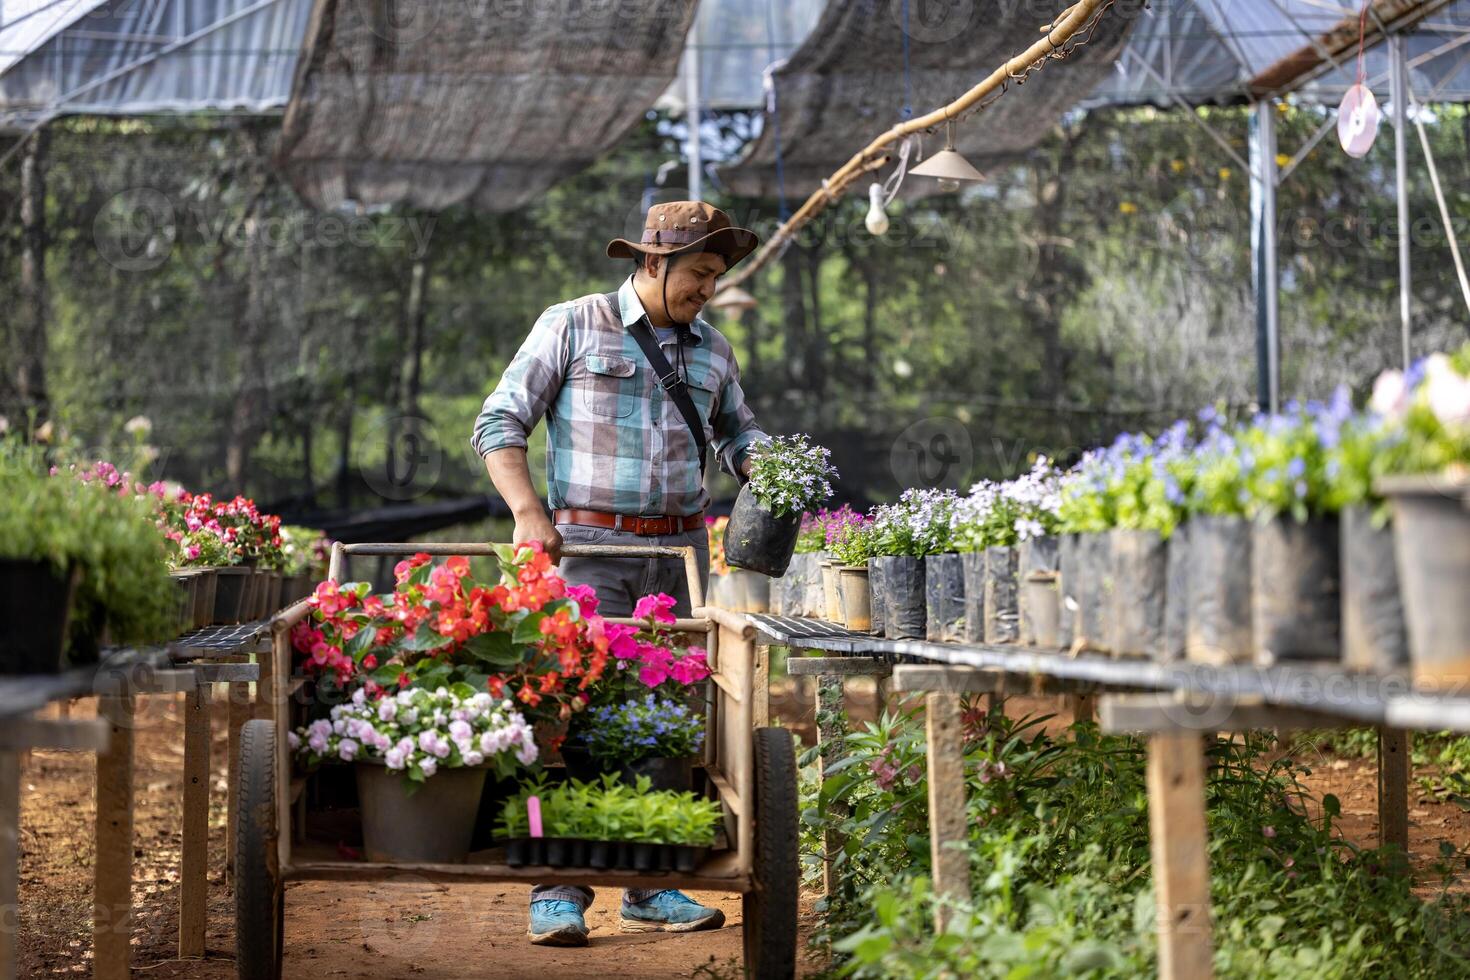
[470, 306, 572, 457]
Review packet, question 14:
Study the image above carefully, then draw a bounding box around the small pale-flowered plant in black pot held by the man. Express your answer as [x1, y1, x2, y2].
[725, 433, 836, 577]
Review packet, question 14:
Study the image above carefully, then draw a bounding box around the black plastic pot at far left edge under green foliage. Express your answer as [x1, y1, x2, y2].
[0, 558, 78, 674]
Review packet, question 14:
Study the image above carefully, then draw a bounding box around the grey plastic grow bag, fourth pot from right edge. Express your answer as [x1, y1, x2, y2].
[1185, 516, 1255, 666]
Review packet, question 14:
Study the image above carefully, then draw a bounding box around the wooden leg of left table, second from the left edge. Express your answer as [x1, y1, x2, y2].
[93, 693, 135, 980]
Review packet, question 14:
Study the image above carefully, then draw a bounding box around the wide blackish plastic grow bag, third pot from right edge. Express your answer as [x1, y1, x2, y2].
[1251, 517, 1342, 667]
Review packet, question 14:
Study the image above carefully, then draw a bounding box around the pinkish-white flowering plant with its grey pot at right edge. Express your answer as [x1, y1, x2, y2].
[1373, 344, 1470, 688]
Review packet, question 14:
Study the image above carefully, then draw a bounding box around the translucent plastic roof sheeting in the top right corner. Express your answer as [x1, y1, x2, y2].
[1083, 0, 1470, 106]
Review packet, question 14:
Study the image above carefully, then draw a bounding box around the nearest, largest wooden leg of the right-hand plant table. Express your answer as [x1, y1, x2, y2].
[1148, 735, 1214, 980]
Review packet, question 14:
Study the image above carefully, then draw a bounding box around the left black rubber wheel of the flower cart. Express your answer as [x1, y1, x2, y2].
[235, 718, 285, 980]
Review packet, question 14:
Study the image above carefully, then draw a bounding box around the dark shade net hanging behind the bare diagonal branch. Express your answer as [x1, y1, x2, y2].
[720, 0, 1136, 197]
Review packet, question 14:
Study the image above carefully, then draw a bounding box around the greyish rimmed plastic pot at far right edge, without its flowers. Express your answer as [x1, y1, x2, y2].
[1376, 476, 1470, 689]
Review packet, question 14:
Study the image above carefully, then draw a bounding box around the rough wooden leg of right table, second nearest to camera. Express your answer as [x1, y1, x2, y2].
[925, 692, 970, 932]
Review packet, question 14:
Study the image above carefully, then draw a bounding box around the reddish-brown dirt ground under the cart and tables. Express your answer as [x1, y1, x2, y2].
[19, 682, 1470, 980]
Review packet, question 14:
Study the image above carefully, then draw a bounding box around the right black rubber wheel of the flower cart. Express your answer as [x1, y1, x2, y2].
[741, 729, 797, 980]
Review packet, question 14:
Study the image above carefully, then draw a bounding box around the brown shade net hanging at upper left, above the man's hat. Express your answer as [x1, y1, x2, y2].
[276, 0, 695, 212]
